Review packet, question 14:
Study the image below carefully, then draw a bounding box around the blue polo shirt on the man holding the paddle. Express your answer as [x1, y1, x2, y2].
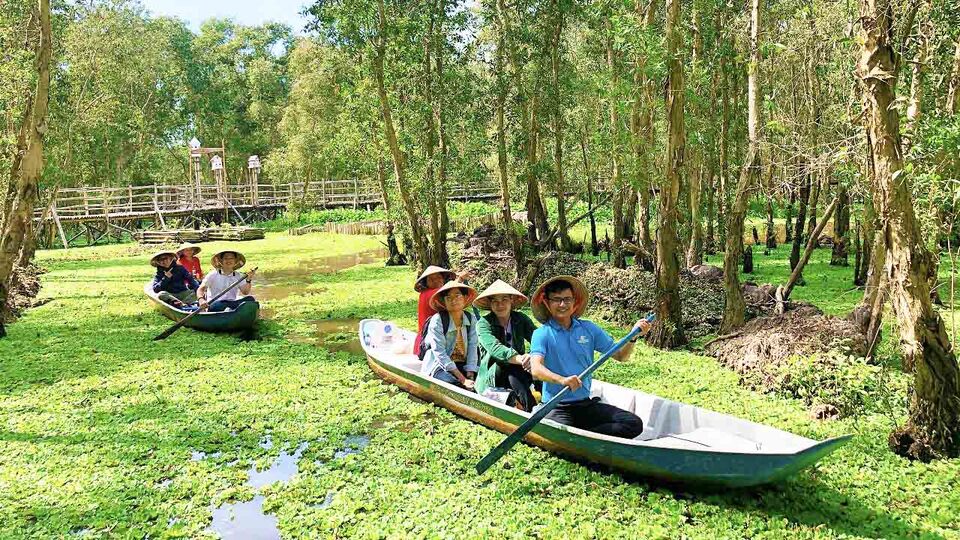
[530, 318, 614, 403]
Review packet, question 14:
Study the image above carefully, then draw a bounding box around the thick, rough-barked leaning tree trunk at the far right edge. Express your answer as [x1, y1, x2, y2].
[857, 0, 960, 460]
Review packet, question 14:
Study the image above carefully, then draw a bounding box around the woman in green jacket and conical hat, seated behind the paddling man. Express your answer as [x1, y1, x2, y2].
[474, 279, 536, 412]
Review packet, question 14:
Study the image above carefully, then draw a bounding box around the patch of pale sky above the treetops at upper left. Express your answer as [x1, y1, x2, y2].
[141, 0, 310, 34]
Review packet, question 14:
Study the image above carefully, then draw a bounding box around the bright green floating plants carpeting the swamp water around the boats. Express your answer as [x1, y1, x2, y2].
[0, 234, 960, 539]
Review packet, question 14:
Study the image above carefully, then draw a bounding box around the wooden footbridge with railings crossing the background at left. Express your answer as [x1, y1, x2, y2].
[34, 180, 500, 248]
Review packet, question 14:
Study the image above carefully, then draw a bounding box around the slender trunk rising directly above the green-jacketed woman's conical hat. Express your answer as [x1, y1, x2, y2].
[496, 0, 526, 279]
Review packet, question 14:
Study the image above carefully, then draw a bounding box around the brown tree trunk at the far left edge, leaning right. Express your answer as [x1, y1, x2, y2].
[0, 0, 53, 321]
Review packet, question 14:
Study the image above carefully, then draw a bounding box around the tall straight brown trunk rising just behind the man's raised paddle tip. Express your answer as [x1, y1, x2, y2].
[649, 0, 686, 348]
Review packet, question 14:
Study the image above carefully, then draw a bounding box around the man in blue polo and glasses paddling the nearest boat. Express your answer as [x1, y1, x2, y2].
[530, 276, 650, 439]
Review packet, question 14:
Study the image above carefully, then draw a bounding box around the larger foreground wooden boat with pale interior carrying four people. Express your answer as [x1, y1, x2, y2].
[360, 319, 850, 487]
